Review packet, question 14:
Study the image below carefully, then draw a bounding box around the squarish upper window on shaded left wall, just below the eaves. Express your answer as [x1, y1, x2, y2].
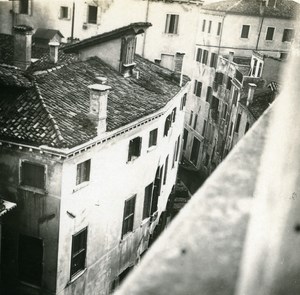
[21, 161, 45, 189]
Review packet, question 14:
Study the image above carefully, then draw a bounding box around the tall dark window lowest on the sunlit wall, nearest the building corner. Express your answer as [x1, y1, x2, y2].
[70, 227, 87, 278]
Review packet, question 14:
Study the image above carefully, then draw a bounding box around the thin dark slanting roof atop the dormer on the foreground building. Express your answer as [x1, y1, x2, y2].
[63, 22, 152, 53]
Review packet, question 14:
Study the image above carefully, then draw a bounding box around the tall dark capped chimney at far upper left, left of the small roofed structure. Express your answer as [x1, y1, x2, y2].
[13, 25, 33, 70]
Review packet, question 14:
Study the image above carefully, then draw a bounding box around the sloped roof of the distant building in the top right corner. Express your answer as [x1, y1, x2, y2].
[202, 0, 299, 19]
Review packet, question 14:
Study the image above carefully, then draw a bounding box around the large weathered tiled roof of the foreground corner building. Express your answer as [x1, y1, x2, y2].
[0, 56, 188, 147]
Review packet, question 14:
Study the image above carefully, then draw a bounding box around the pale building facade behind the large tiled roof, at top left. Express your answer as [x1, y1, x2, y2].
[0, 0, 203, 74]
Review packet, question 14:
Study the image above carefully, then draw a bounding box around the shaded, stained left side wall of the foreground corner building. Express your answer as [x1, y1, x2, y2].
[0, 147, 62, 294]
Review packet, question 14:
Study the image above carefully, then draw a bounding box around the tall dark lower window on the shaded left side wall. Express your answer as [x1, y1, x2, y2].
[18, 235, 43, 286]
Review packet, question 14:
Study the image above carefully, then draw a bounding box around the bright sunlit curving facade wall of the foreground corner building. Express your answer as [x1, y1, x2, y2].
[57, 88, 188, 295]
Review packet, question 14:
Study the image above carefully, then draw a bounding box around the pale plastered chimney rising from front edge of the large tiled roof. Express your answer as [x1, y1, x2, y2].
[88, 84, 111, 134]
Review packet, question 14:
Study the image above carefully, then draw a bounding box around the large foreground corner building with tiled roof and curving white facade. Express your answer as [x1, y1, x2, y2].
[0, 23, 189, 294]
